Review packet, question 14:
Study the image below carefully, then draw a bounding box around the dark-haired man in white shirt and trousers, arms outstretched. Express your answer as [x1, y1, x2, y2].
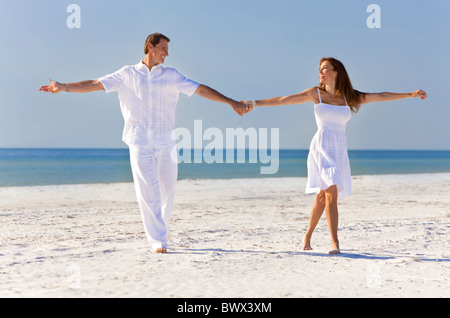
[39, 33, 246, 253]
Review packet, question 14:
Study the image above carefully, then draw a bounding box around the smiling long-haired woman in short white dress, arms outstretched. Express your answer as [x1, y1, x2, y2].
[246, 57, 427, 254]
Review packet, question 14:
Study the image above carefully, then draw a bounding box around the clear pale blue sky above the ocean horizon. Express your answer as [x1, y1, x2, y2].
[0, 0, 450, 149]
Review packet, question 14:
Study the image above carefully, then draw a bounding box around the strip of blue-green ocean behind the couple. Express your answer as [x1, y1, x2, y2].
[0, 149, 450, 187]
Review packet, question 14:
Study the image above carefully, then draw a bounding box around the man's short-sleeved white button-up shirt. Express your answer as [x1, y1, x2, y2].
[99, 61, 200, 146]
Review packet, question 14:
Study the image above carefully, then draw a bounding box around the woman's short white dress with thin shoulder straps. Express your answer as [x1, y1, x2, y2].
[305, 89, 352, 197]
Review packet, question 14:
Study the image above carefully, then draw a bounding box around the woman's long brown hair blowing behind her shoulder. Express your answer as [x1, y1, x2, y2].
[319, 57, 364, 113]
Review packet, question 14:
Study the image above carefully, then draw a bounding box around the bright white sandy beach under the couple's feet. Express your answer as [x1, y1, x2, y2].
[0, 174, 450, 297]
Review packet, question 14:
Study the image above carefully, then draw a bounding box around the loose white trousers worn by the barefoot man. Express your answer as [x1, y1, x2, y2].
[129, 145, 178, 249]
